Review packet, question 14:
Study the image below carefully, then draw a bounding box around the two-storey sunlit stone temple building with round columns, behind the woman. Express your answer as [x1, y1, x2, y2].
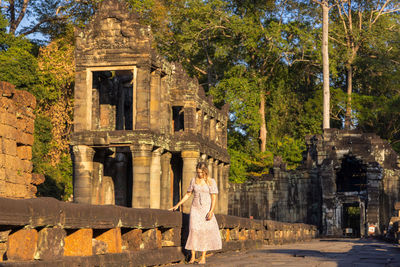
[72, 0, 229, 213]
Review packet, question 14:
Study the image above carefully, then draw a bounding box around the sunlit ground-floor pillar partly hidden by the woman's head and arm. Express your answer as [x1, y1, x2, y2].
[181, 150, 200, 213]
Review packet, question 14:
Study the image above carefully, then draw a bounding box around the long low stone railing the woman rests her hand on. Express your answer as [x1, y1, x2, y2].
[0, 198, 317, 267]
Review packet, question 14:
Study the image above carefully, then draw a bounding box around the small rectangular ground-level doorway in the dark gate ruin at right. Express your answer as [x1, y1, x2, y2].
[342, 202, 361, 237]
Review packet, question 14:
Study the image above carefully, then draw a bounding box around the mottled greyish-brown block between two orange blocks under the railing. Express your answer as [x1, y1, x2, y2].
[35, 228, 67, 260]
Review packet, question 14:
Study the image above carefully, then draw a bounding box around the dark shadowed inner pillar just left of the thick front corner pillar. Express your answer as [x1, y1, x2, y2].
[114, 152, 128, 206]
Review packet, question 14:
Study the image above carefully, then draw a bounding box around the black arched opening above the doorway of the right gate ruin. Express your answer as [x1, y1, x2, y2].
[336, 155, 367, 195]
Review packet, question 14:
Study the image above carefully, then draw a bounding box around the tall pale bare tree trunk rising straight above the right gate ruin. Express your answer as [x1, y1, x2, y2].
[322, 0, 330, 129]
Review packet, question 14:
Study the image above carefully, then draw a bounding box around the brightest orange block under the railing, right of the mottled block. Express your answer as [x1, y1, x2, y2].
[64, 229, 93, 256]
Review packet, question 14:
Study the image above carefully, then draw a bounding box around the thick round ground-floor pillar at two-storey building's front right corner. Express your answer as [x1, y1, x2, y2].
[131, 144, 153, 208]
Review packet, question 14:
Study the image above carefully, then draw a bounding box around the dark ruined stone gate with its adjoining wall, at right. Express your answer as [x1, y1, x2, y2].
[229, 129, 400, 239]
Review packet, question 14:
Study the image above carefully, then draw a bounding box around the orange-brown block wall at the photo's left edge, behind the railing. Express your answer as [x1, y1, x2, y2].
[0, 82, 43, 198]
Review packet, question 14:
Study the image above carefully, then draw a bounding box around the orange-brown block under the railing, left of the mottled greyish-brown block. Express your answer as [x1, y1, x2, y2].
[7, 229, 38, 261]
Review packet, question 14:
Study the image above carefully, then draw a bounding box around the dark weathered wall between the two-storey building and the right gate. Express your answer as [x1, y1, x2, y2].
[228, 165, 321, 225]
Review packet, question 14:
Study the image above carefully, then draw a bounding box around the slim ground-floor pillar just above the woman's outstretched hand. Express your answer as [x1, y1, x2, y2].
[160, 152, 173, 210]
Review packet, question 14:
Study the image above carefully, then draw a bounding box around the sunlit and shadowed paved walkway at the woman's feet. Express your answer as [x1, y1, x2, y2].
[164, 239, 400, 267]
